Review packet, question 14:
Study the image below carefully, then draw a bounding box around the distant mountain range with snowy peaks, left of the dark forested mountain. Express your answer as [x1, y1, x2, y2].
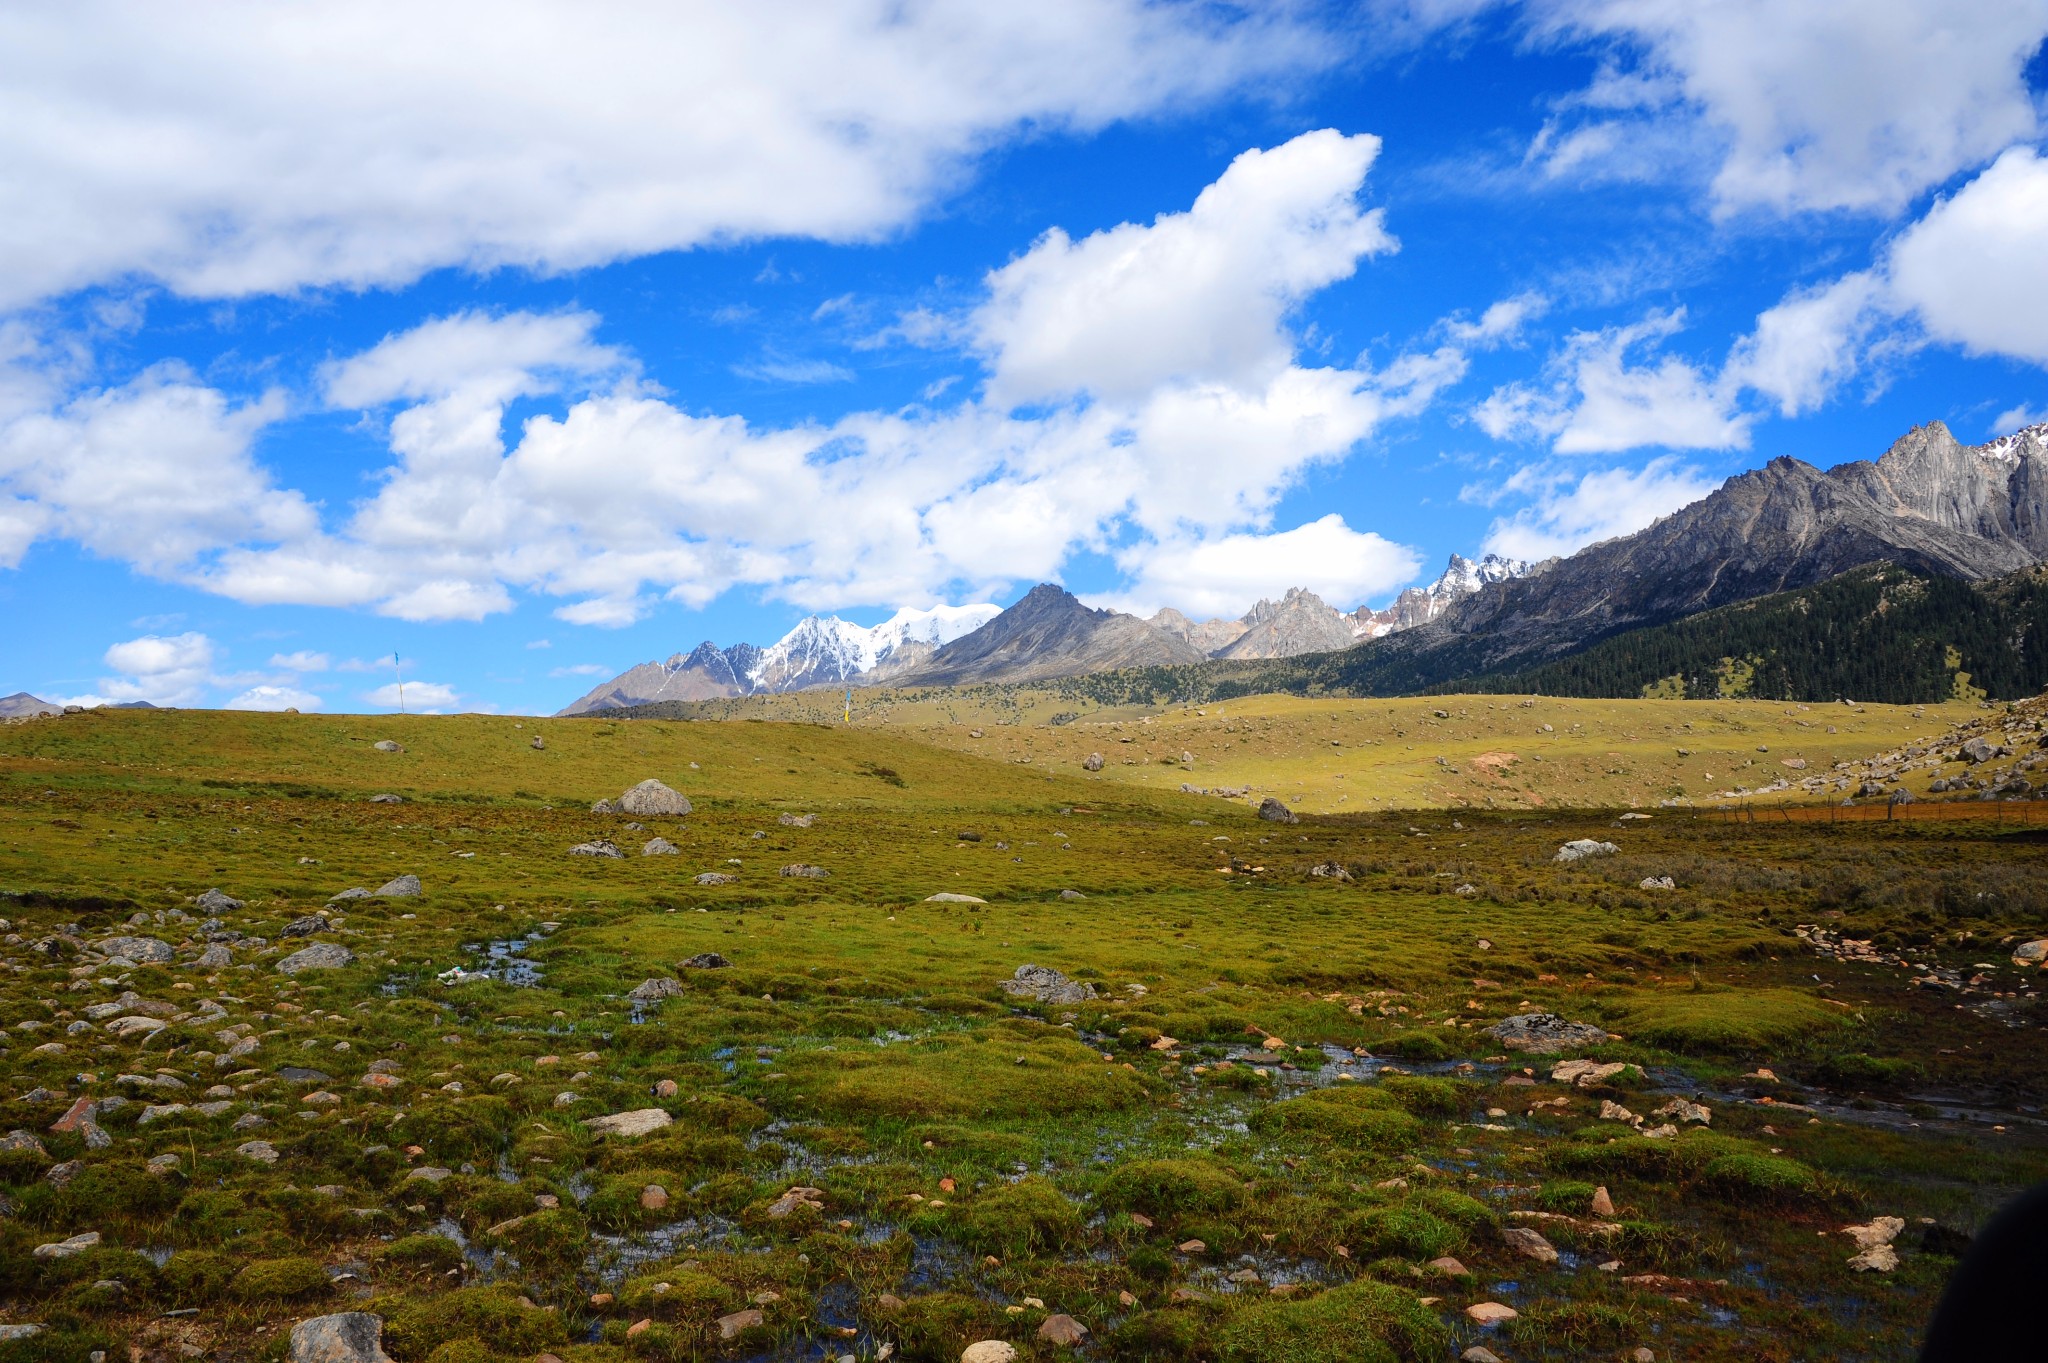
[561, 555, 1536, 714]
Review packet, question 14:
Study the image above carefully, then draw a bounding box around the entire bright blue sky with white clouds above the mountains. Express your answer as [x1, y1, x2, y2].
[0, 0, 2048, 712]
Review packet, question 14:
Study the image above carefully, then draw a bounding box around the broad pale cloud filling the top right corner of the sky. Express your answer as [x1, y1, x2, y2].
[1526, 0, 2048, 213]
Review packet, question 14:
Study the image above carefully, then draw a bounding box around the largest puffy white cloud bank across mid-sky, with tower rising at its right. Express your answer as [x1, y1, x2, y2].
[75, 131, 1441, 626]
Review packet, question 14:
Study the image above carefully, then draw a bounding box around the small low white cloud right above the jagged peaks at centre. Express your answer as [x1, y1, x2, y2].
[1112, 514, 1421, 618]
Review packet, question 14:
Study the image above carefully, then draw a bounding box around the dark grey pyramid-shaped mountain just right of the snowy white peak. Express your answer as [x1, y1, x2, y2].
[891, 583, 1204, 686]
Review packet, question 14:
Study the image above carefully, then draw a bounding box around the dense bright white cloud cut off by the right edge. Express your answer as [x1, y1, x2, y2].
[1890, 147, 2048, 364]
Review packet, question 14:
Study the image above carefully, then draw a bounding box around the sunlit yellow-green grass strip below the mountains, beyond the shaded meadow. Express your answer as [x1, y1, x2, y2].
[659, 688, 1980, 812]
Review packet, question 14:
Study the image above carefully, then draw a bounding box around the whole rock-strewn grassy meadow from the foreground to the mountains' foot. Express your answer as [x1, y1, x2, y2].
[0, 698, 2048, 1363]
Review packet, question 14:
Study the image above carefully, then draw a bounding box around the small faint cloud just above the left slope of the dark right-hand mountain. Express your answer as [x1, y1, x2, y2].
[1485, 454, 1714, 561]
